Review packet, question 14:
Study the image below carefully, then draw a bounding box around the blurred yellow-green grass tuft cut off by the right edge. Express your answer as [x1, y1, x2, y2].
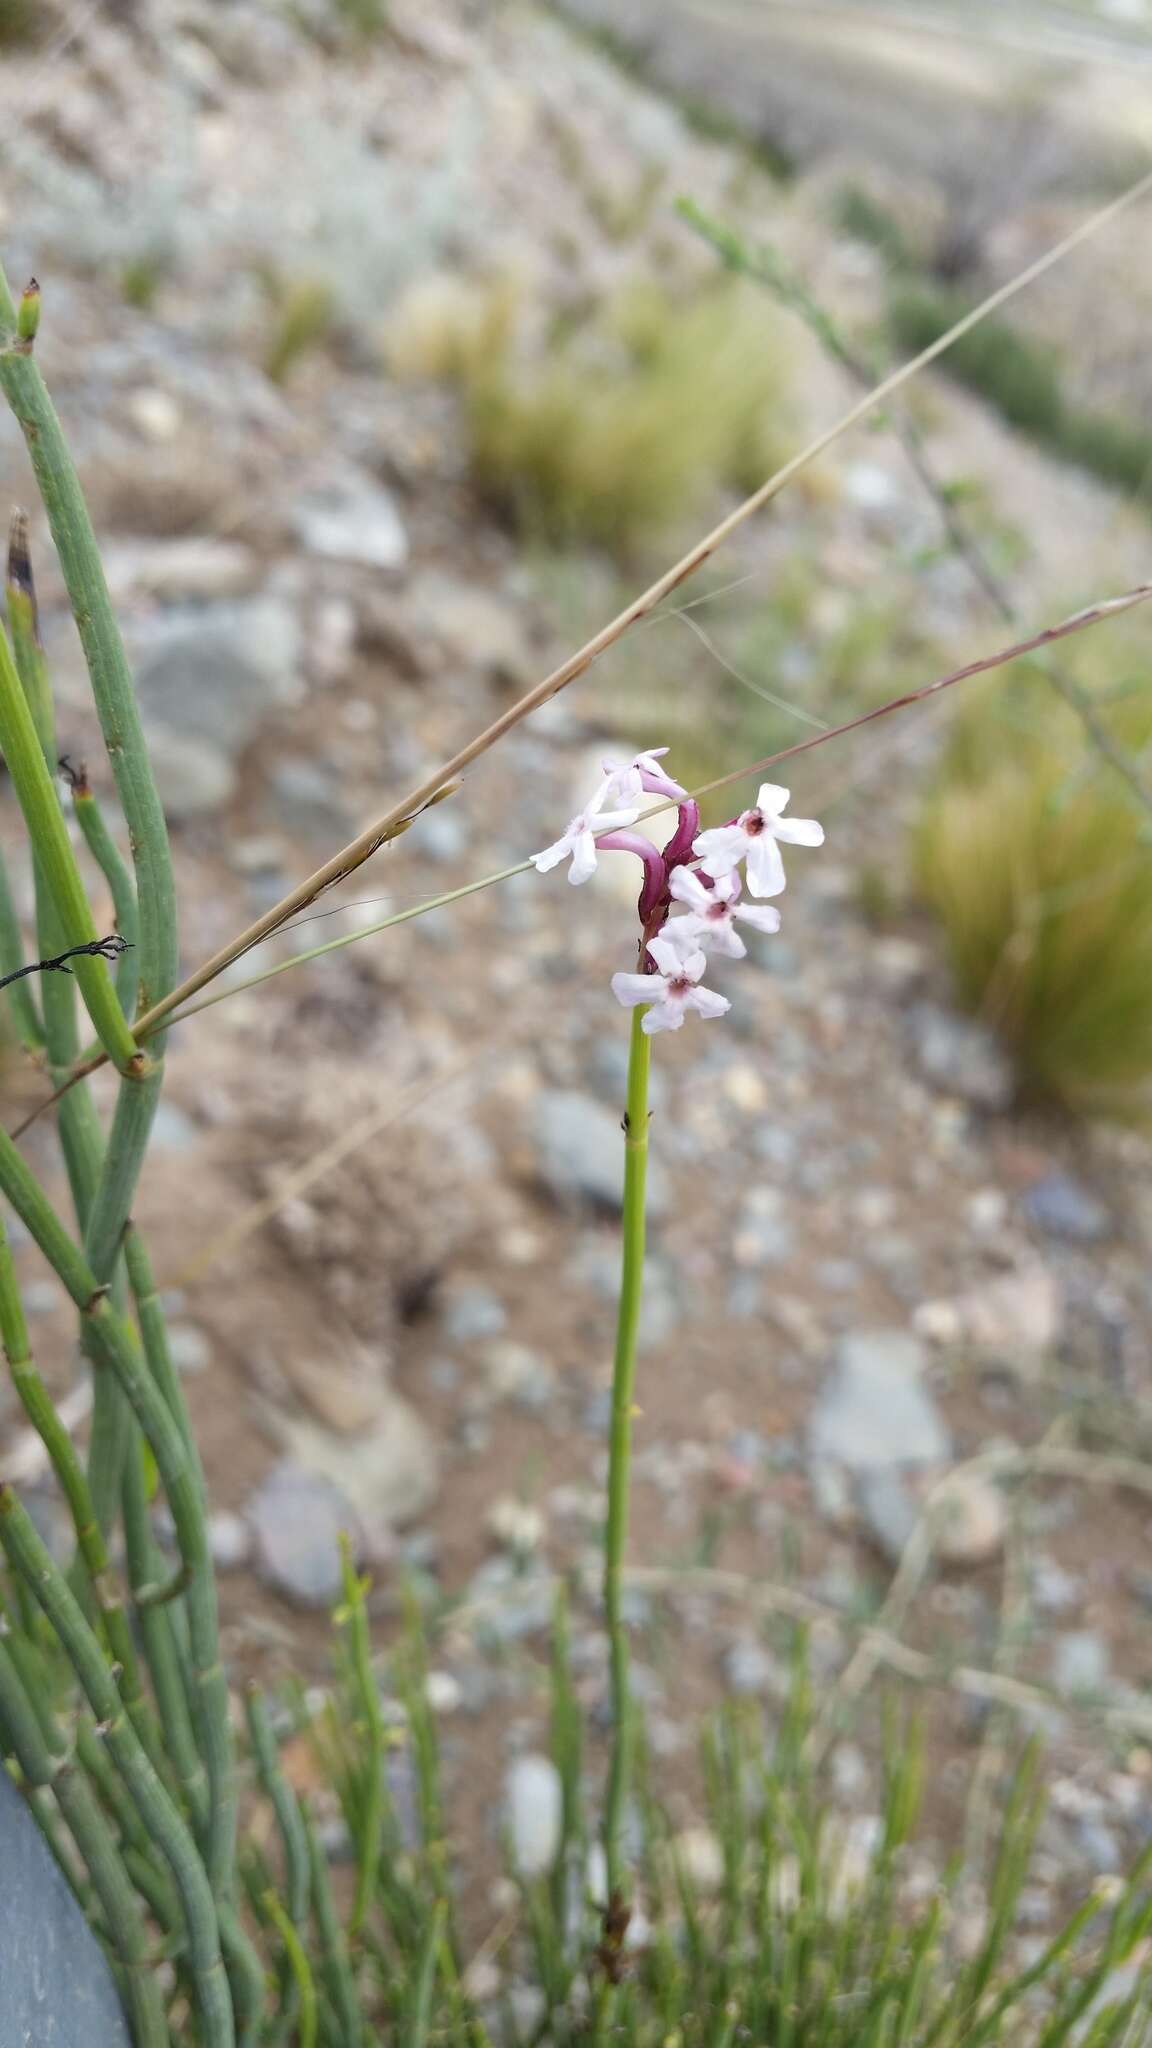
[916, 664, 1152, 1116]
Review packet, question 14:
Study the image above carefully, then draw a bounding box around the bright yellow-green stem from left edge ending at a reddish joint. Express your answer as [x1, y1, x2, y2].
[0, 618, 141, 1073]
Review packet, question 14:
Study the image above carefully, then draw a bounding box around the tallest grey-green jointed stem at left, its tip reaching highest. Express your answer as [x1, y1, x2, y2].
[0, 268, 178, 1028]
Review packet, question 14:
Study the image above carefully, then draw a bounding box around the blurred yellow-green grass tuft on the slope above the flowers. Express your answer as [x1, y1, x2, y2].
[389, 281, 785, 557]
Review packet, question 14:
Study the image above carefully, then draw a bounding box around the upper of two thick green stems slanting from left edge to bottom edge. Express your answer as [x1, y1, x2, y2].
[0, 1487, 236, 2048]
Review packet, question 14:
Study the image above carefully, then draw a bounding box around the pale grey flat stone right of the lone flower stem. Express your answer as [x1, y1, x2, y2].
[808, 1329, 951, 1473]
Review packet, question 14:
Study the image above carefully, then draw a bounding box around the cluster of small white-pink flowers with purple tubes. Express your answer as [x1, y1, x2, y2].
[533, 748, 824, 1034]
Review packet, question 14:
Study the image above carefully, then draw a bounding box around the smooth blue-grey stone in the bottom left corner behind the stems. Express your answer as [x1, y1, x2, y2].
[0, 1769, 131, 2048]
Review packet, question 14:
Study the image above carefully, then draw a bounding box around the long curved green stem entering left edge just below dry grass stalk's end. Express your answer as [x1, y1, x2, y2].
[0, 1130, 236, 1901]
